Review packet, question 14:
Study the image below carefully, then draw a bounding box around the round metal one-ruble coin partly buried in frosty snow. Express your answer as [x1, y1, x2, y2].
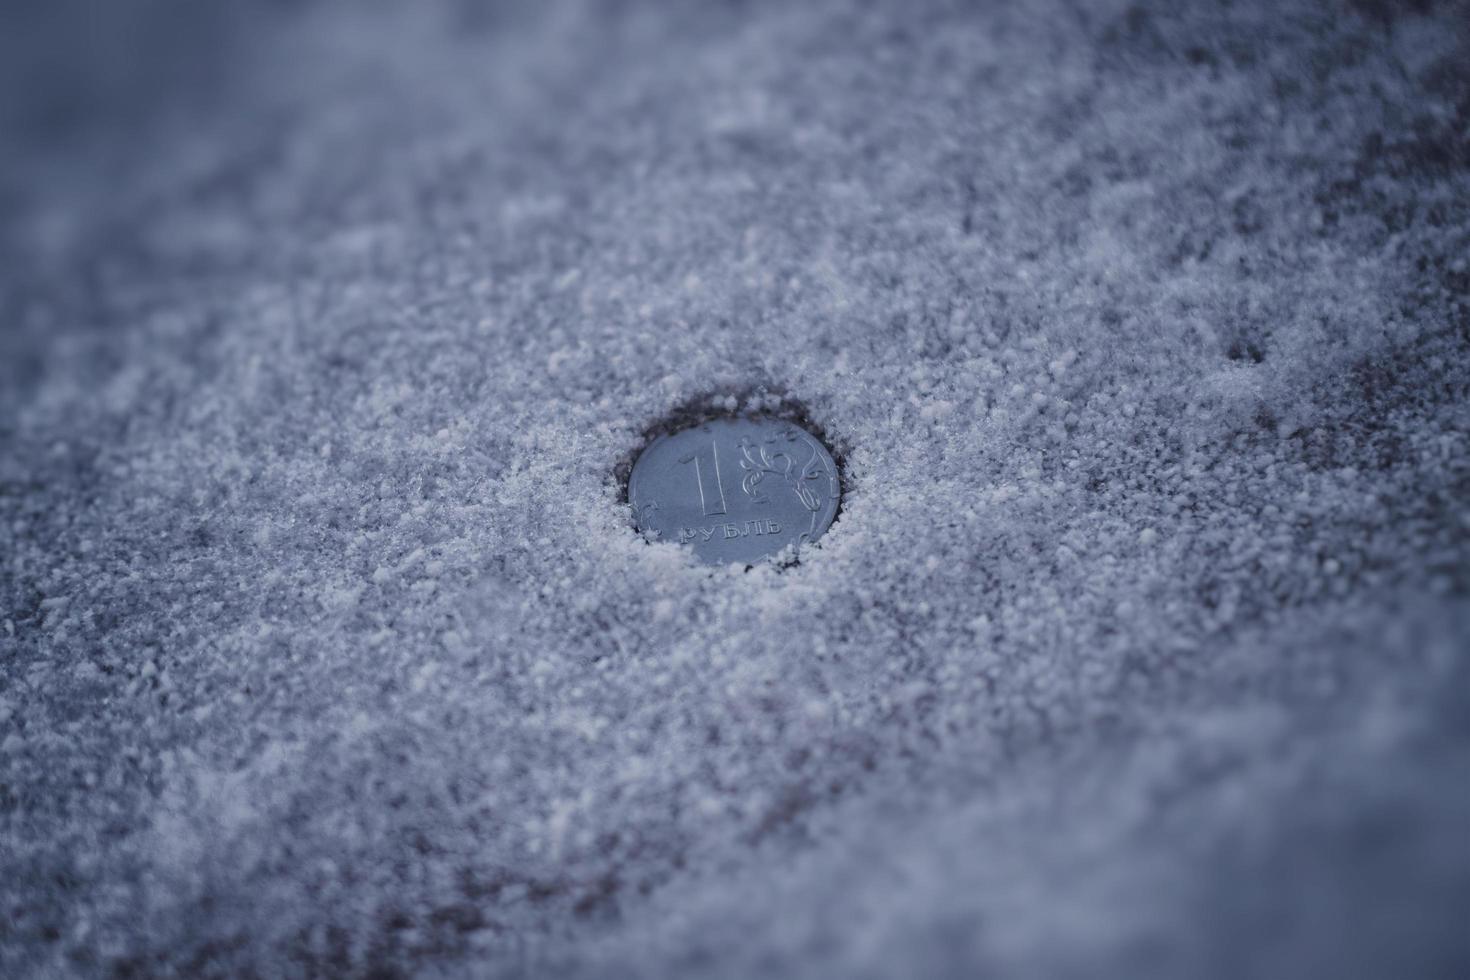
[628, 417, 842, 563]
